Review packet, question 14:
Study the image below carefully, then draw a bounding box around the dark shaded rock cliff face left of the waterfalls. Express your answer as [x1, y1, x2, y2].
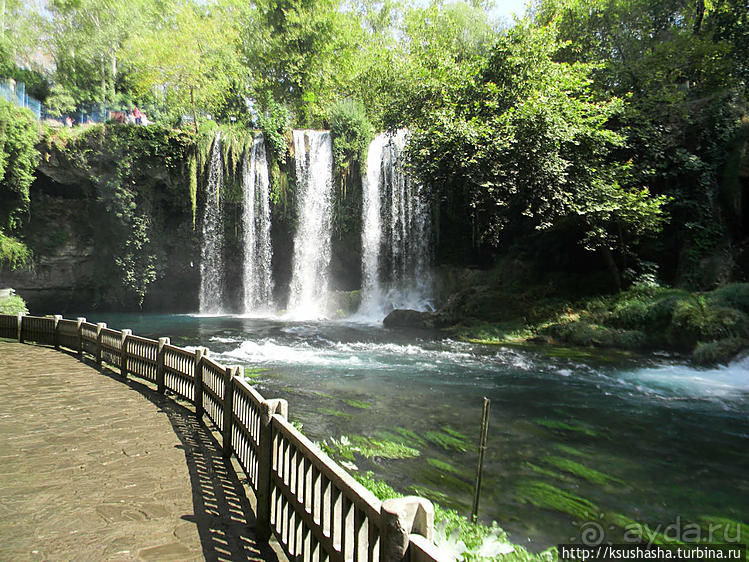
[0, 124, 199, 314]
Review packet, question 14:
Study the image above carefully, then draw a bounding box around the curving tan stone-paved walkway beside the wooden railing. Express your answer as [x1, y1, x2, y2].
[0, 342, 276, 560]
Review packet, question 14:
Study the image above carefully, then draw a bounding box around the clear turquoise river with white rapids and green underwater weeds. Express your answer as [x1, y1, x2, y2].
[79, 314, 749, 551]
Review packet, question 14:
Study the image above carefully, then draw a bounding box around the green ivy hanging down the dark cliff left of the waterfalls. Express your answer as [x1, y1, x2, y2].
[43, 125, 195, 306]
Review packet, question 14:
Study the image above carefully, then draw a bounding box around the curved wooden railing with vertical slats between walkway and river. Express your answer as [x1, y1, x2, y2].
[0, 315, 442, 562]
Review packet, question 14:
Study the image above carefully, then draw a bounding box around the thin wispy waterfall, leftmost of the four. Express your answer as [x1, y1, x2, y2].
[200, 133, 224, 314]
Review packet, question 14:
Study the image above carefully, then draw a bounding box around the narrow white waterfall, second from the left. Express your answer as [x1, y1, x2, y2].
[242, 135, 273, 313]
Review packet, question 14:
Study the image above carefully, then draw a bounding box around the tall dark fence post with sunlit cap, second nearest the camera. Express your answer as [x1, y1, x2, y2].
[255, 398, 289, 542]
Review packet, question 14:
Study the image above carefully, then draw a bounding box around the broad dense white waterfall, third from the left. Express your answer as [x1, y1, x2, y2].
[287, 131, 333, 319]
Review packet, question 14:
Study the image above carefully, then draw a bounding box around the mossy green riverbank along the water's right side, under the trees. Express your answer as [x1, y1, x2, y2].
[441, 283, 749, 365]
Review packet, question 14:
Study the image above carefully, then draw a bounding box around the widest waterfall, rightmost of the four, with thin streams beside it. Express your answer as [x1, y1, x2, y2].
[359, 130, 433, 320]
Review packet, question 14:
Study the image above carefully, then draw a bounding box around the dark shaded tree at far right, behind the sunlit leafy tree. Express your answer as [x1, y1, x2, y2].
[535, 0, 749, 285]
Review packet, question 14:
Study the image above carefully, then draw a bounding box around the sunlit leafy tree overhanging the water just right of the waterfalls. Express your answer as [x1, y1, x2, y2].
[410, 21, 664, 285]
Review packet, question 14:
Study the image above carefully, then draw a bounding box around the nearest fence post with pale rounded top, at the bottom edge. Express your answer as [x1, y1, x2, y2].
[380, 496, 434, 561]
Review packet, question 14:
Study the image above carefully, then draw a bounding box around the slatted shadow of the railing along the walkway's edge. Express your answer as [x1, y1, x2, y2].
[86, 360, 279, 562]
